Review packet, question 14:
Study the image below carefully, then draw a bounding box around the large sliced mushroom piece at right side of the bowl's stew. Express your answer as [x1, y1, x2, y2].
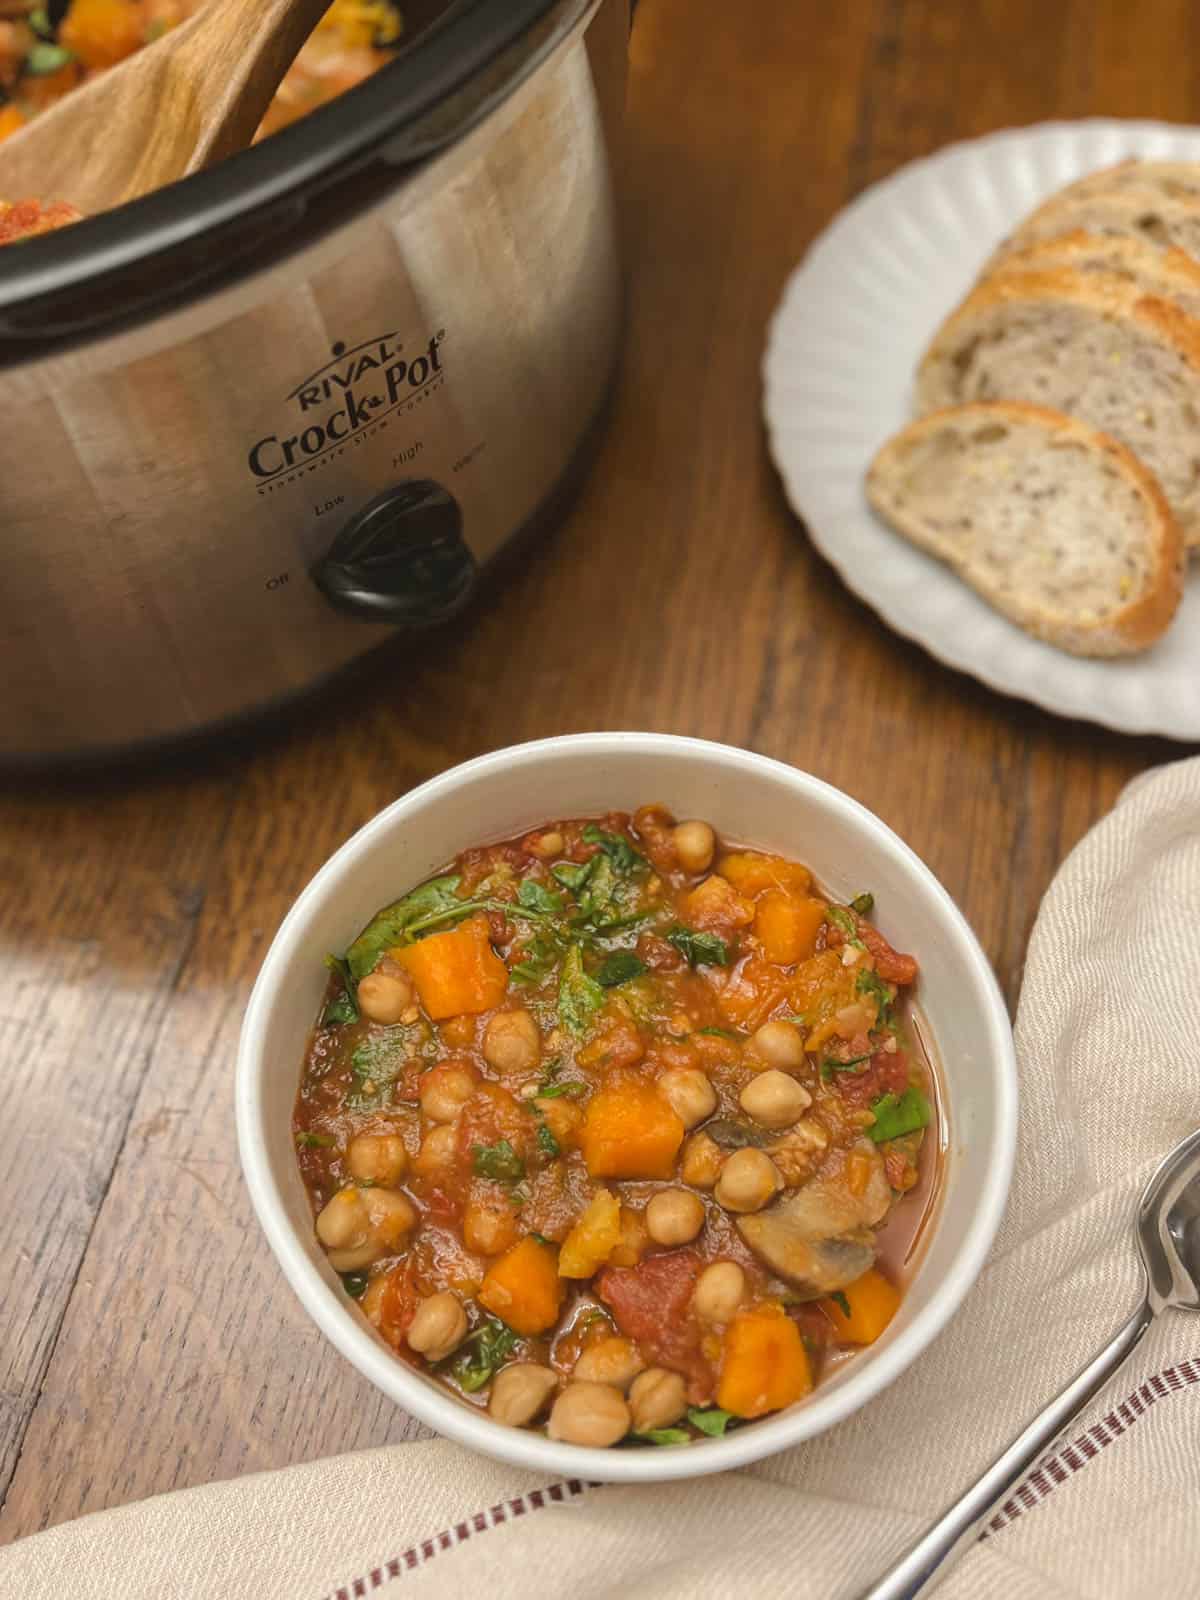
[738, 1139, 891, 1299]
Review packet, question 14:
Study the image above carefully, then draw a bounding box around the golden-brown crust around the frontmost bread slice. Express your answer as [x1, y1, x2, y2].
[867, 400, 1186, 656]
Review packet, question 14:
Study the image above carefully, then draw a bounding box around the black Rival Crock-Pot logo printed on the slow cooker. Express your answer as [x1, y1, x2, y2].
[246, 328, 446, 486]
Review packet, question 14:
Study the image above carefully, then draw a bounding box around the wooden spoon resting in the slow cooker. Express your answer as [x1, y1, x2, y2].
[0, 0, 339, 214]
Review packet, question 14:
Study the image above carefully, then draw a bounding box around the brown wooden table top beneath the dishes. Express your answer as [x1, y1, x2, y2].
[0, 0, 1200, 1539]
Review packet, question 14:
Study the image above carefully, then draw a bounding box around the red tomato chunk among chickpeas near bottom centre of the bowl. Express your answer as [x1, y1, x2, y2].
[595, 1250, 712, 1405]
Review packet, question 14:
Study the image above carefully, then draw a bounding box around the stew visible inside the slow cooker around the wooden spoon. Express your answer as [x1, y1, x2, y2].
[0, 0, 403, 245]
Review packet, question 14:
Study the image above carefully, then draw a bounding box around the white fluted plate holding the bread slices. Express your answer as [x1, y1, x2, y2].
[763, 120, 1200, 741]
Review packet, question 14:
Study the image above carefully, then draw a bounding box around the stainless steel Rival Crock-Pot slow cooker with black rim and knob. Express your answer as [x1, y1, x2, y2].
[0, 0, 627, 765]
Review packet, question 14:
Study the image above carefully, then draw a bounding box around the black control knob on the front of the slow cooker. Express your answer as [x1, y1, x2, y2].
[312, 478, 475, 627]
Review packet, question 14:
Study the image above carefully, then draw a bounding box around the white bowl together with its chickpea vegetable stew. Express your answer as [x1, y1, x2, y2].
[237, 733, 1016, 1480]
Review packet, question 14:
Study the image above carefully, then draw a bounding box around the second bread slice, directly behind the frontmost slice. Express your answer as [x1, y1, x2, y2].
[915, 267, 1200, 547]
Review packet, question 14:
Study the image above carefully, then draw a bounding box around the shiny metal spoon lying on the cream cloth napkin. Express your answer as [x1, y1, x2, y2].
[859, 1130, 1200, 1600]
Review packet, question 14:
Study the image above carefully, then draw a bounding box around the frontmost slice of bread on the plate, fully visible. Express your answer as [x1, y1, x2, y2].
[867, 400, 1184, 656]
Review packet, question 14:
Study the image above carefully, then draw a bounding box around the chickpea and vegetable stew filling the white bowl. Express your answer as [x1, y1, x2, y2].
[294, 805, 938, 1446]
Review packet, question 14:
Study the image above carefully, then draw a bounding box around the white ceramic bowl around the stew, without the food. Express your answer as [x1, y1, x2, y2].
[237, 733, 1018, 1482]
